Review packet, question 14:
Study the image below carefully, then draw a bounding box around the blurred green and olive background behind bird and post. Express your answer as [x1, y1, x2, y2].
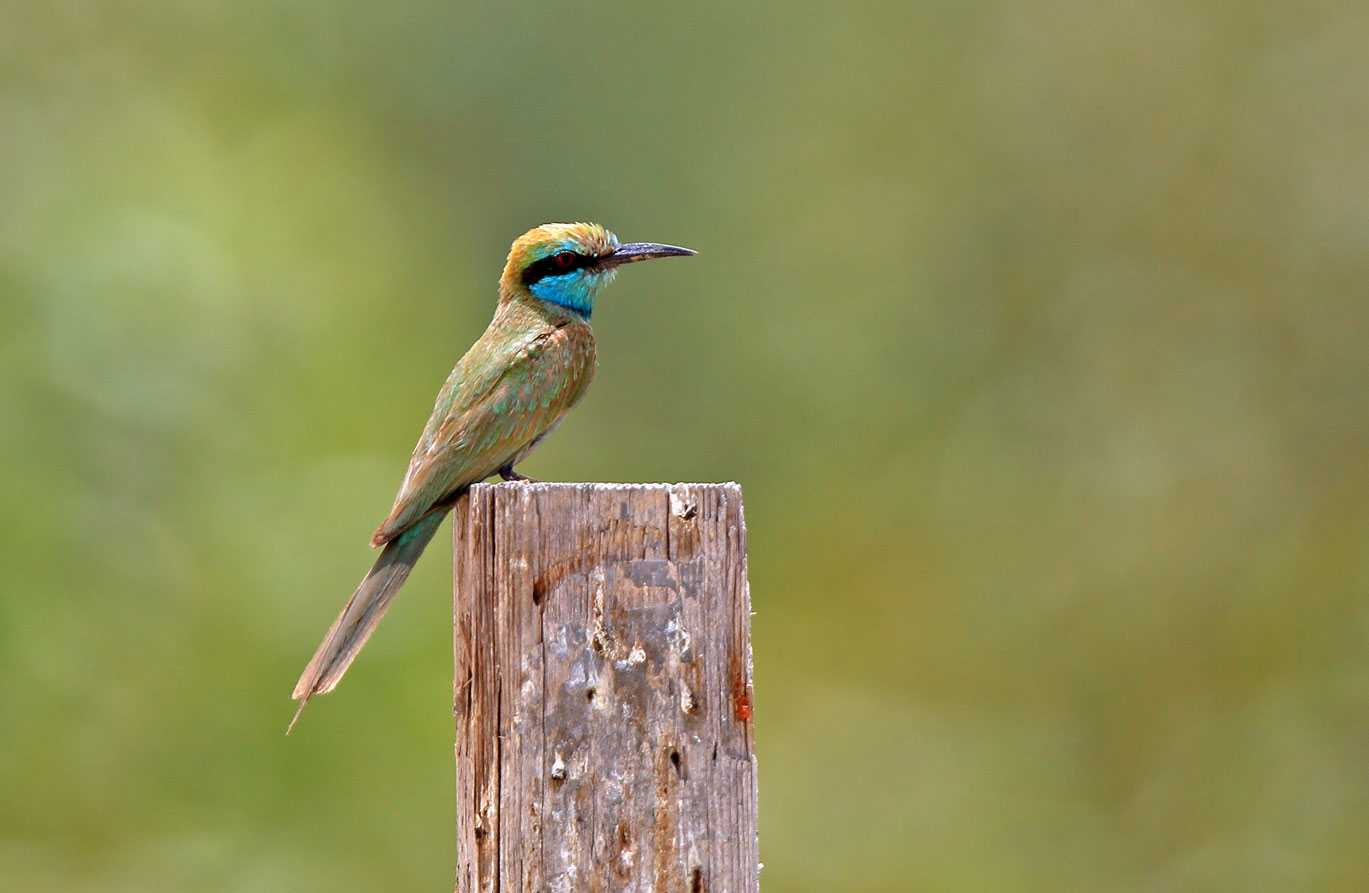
[0, 0, 1369, 893]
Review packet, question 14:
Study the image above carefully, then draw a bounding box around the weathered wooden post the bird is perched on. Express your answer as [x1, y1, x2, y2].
[452, 483, 758, 893]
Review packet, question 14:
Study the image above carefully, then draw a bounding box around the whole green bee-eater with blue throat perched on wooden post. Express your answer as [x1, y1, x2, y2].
[286, 223, 697, 734]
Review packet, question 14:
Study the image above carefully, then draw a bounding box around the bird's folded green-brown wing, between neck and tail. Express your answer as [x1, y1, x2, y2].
[371, 323, 594, 545]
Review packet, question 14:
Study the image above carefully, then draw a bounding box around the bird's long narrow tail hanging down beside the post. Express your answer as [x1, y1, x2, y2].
[285, 511, 446, 734]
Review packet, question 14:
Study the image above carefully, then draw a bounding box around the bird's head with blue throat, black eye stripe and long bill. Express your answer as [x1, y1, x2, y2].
[500, 223, 694, 319]
